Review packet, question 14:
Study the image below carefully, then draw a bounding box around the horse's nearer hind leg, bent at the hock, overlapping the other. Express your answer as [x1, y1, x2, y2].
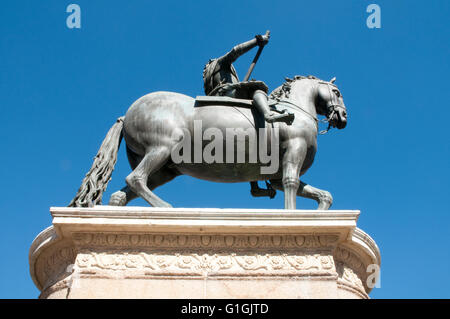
[125, 146, 172, 207]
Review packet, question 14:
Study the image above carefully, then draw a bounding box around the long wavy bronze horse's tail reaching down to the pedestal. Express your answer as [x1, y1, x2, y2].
[69, 116, 125, 207]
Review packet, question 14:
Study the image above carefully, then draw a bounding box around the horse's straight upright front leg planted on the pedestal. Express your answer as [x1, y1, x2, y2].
[281, 139, 307, 209]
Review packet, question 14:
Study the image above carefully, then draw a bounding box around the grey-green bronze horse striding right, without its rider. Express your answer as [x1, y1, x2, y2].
[69, 76, 347, 209]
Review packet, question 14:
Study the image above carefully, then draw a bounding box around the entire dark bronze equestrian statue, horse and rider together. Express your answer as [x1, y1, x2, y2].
[69, 31, 347, 210]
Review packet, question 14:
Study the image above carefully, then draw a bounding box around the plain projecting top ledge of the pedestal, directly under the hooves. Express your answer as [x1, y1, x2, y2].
[50, 206, 359, 236]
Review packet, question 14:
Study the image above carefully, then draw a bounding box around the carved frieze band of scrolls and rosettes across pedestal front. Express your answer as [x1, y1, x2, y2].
[76, 251, 335, 276]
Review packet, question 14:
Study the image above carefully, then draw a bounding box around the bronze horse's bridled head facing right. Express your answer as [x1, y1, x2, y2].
[316, 78, 347, 129]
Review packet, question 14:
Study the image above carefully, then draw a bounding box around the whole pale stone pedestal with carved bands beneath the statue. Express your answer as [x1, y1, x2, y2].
[29, 206, 380, 298]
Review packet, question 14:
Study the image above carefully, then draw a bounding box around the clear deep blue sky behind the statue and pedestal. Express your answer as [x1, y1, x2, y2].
[0, 0, 450, 298]
